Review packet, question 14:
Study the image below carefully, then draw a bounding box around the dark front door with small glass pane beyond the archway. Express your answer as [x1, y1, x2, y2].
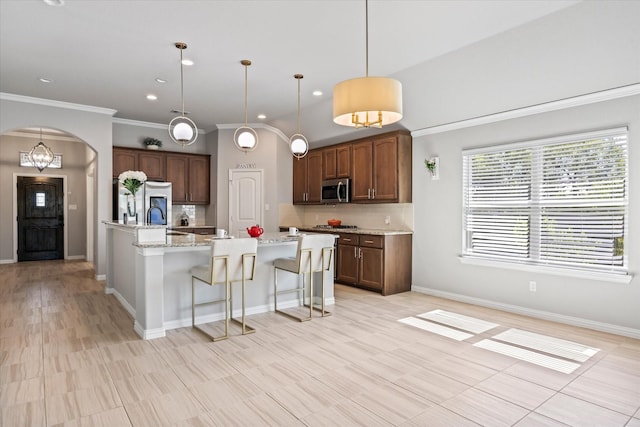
[17, 176, 64, 261]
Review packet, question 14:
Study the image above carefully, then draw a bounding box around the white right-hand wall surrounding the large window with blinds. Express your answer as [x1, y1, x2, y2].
[413, 96, 640, 336]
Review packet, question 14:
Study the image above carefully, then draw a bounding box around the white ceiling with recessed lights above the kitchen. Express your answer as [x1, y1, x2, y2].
[0, 0, 576, 144]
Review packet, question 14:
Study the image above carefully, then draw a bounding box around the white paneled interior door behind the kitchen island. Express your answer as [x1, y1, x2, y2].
[229, 169, 263, 237]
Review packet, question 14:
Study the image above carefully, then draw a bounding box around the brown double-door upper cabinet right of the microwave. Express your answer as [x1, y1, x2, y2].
[351, 131, 411, 203]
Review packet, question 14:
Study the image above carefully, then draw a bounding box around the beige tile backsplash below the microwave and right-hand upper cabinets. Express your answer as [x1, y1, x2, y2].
[279, 203, 413, 230]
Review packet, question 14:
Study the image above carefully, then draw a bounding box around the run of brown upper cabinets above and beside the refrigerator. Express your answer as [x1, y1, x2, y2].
[113, 147, 211, 205]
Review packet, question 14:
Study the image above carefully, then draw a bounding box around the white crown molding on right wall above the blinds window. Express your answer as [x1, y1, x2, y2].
[411, 83, 640, 138]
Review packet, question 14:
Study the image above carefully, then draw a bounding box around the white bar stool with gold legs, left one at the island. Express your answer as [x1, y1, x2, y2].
[191, 238, 258, 341]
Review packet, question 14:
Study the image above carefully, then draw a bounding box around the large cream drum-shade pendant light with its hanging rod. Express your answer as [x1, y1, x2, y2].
[333, 0, 402, 128]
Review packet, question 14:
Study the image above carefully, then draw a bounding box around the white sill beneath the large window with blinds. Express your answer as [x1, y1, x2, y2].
[458, 256, 633, 285]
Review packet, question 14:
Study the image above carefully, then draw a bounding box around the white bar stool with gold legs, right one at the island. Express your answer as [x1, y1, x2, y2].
[273, 234, 335, 322]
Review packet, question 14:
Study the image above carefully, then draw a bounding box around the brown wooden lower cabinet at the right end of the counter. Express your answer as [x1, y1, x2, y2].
[336, 233, 411, 295]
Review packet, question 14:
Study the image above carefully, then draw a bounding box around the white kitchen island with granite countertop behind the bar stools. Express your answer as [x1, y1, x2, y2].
[105, 222, 337, 339]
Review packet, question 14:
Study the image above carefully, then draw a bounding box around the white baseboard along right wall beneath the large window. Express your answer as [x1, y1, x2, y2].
[411, 285, 640, 339]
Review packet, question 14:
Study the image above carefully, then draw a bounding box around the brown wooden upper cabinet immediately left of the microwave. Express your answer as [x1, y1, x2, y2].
[293, 149, 322, 205]
